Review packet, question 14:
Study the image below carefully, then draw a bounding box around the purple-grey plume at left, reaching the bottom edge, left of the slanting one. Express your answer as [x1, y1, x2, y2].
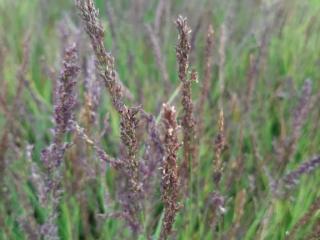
[41, 44, 79, 239]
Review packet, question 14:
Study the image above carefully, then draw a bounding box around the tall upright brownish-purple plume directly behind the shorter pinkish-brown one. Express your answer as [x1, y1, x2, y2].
[176, 16, 195, 186]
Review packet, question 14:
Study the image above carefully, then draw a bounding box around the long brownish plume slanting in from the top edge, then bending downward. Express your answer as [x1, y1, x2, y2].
[76, 0, 140, 233]
